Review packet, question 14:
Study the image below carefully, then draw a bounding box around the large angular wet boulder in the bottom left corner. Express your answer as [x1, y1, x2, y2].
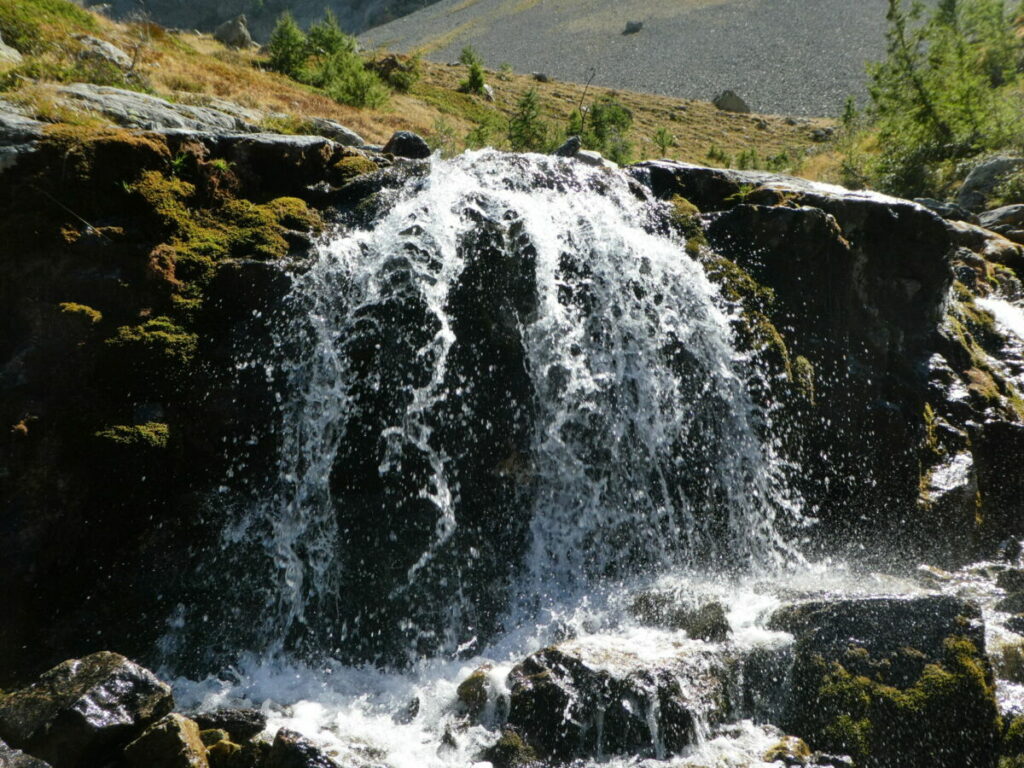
[0, 651, 174, 768]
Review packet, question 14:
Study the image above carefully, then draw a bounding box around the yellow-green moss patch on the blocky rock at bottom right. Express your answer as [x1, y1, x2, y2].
[799, 637, 1000, 768]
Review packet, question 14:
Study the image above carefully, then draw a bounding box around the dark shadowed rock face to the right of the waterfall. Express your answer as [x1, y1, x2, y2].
[633, 162, 1024, 562]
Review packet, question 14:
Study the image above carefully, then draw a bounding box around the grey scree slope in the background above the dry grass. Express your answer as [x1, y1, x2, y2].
[361, 0, 886, 115]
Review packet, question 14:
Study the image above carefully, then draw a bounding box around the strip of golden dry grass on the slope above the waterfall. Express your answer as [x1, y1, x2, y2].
[0, 0, 838, 171]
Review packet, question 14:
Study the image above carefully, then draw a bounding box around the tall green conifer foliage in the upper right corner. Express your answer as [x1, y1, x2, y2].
[841, 0, 1024, 197]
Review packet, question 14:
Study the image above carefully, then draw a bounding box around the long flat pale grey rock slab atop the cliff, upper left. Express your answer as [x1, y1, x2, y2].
[56, 83, 257, 133]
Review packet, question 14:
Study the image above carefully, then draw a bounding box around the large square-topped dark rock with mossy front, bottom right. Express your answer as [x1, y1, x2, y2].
[772, 596, 999, 768]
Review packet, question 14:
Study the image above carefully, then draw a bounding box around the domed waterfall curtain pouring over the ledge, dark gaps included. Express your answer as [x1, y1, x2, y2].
[168, 152, 802, 764]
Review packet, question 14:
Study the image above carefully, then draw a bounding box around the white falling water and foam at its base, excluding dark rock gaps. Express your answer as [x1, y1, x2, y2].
[165, 152, 815, 768]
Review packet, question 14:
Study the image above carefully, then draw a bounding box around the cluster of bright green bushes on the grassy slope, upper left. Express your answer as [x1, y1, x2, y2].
[267, 10, 389, 109]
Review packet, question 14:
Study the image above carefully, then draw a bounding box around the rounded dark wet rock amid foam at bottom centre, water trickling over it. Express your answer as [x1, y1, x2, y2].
[508, 641, 728, 760]
